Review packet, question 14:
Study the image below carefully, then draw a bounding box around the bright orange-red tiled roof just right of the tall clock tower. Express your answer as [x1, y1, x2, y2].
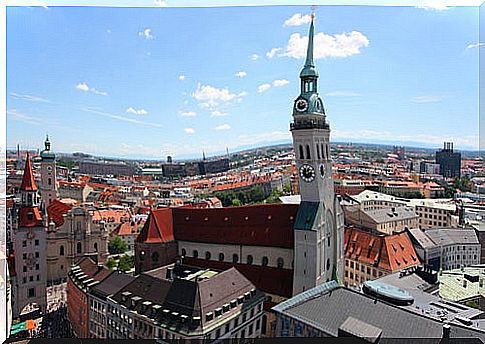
[344, 228, 419, 271]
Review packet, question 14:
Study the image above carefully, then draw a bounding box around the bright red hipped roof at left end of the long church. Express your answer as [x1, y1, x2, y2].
[136, 208, 174, 244]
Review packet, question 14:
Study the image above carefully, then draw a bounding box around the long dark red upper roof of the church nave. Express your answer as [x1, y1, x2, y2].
[172, 204, 298, 249]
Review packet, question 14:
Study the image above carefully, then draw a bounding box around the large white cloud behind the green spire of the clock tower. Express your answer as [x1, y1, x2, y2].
[283, 31, 369, 59]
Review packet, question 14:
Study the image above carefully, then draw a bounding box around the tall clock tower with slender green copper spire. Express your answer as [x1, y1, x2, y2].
[290, 16, 344, 295]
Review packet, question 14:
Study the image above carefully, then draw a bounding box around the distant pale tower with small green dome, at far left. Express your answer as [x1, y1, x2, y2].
[40, 136, 57, 210]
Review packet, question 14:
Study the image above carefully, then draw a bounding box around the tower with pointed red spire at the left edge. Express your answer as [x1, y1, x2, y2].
[12, 155, 47, 318]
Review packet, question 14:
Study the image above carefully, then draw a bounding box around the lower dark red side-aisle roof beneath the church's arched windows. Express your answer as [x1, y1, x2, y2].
[183, 257, 293, 297]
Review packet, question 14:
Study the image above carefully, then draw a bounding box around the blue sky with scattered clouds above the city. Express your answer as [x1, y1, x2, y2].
[7, 6, 480, 159]
